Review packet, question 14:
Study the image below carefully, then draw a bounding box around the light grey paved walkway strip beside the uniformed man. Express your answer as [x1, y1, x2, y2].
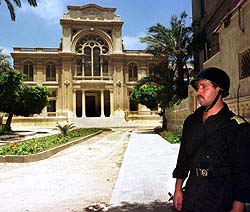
[110, 130, 179, 210]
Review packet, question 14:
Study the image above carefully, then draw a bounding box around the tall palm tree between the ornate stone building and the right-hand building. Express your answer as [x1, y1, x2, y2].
[141, 12, 192, 105]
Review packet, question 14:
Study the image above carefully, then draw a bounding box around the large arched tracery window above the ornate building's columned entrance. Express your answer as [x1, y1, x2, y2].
[75, 35, 109, 77]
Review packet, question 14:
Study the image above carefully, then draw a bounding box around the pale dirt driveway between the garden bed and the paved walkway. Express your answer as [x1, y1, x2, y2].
[0, 129, 130, 212]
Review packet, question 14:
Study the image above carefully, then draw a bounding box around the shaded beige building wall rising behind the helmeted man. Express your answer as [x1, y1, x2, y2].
[190, 0, 250, 120]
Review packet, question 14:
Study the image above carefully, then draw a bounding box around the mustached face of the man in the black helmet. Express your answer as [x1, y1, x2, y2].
[196, 80, 220, 107]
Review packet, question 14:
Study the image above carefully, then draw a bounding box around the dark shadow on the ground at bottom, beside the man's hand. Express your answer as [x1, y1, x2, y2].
[108, 201, 177, 212]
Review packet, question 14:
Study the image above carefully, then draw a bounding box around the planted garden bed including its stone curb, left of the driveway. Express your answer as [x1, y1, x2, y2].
[0, 129, 102, 163]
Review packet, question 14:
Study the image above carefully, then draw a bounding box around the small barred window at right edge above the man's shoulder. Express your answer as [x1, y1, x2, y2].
[240, 49, 250, 79]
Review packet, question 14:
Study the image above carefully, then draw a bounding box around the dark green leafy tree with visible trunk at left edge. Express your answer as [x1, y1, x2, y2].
[0, 52, 49, 131]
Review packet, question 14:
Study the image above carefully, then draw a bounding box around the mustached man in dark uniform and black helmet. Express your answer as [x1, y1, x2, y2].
[173, 67, 250, 212]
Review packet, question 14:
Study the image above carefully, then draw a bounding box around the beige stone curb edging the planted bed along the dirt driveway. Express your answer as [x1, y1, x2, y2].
[0, 130, 102, 163]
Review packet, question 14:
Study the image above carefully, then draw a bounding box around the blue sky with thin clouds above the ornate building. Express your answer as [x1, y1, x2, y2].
[0, 0, 192, 57]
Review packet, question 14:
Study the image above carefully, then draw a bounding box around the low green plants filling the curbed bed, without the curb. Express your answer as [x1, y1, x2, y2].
[0, 128, 100, 155]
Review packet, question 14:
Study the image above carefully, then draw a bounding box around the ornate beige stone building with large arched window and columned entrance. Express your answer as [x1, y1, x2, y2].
[11, 4, 158, 124]
